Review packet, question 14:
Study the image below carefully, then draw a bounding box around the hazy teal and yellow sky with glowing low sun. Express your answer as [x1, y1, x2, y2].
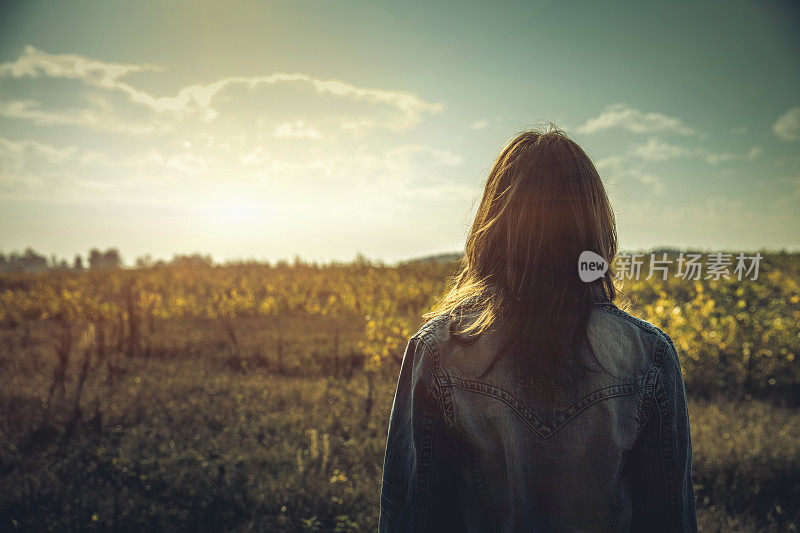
[0, 0, 800, 263]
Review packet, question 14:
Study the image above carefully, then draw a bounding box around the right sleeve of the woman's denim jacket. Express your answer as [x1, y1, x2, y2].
[626, 337, 697, 531]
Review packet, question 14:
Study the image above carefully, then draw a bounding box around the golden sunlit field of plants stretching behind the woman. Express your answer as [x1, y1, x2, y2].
[0, 254, 800, 531]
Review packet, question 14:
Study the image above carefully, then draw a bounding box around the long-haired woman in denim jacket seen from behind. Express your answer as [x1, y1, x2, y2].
[379, 127, 697, 531]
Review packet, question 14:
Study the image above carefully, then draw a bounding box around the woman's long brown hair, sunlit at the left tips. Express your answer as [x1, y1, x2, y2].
[423, 124, 617, 379]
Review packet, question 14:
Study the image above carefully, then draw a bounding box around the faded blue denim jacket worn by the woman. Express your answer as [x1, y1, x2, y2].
[379, 288, 697, 532]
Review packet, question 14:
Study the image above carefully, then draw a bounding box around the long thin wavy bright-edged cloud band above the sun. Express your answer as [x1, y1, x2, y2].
[0, 46, 443, 129]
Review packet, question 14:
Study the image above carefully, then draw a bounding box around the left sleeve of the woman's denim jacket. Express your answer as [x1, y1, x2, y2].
[378, 336, 459, 532]
